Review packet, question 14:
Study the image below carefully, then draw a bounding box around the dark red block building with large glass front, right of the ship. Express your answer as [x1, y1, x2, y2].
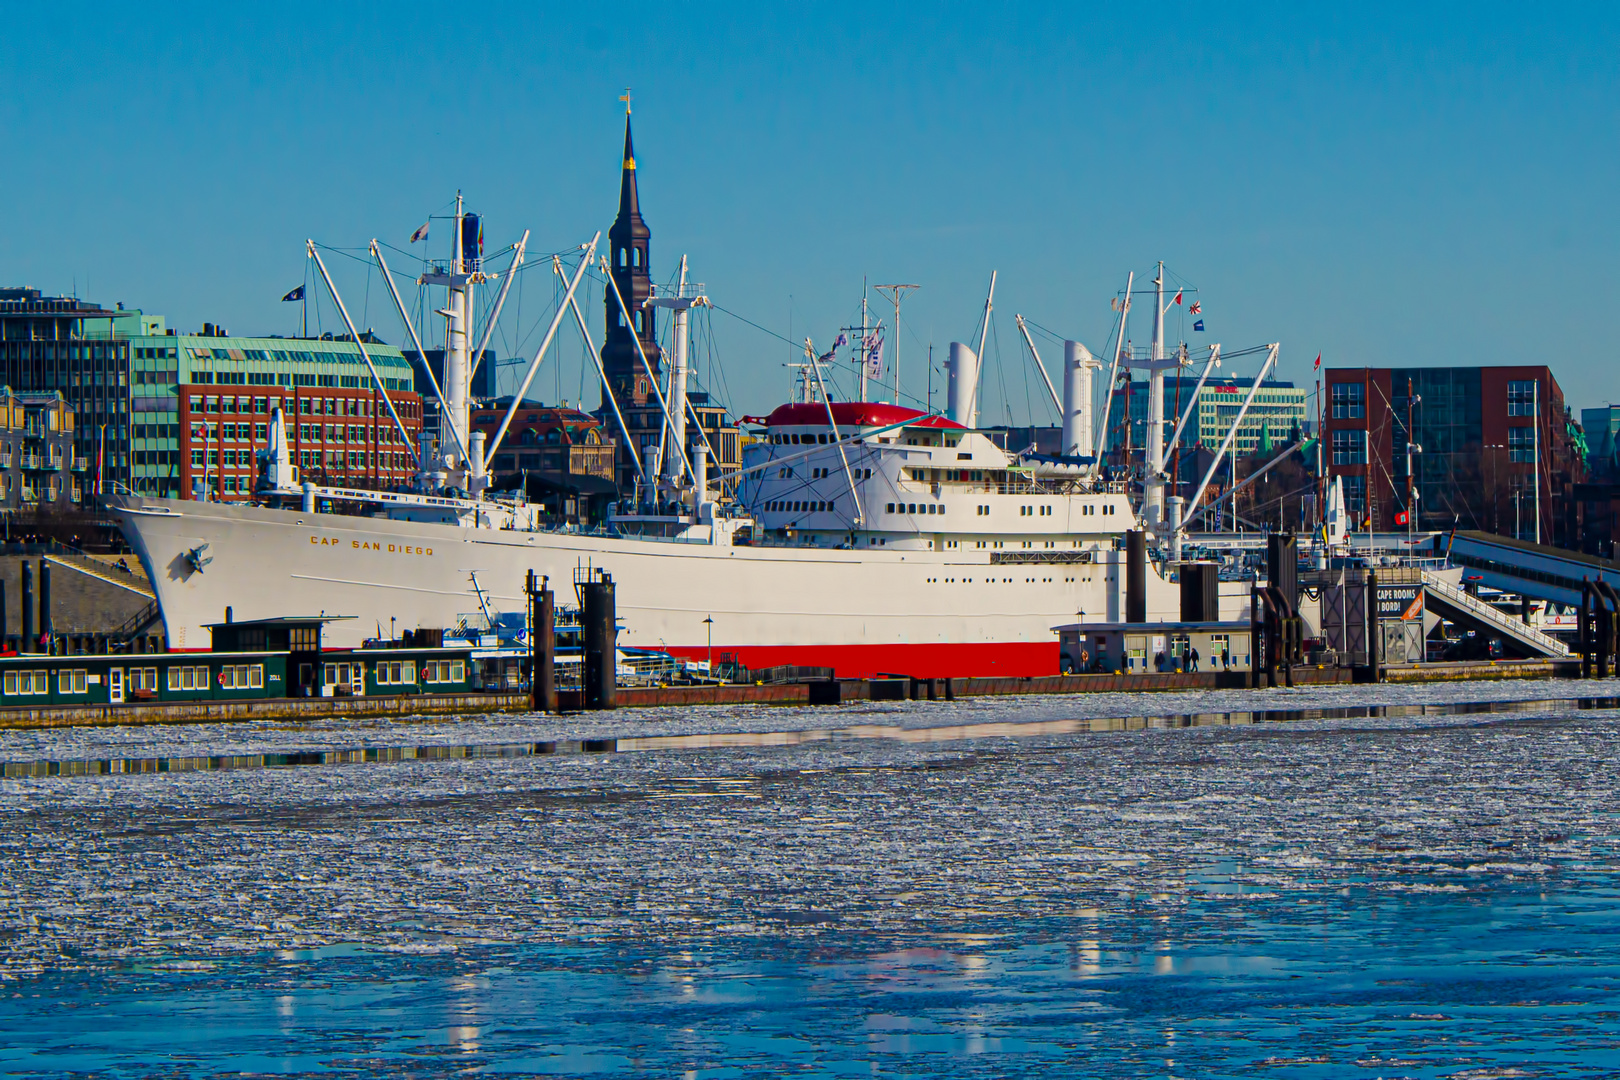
[1324, 364, 1586, 547]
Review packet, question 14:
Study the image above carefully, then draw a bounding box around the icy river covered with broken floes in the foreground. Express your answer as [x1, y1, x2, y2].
[0, 682, 1620, 1080]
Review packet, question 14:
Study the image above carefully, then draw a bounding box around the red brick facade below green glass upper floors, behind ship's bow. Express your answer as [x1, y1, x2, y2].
[178, 384, 421, 502]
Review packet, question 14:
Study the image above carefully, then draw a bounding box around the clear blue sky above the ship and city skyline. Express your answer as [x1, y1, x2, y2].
[0, 3, 1620, 423]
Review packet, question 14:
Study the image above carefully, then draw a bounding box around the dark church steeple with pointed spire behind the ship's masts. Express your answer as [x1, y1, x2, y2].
[603, 104, 663, 408]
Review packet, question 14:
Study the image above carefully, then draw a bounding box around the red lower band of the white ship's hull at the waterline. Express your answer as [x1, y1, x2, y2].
[664, 641, 1059, 678]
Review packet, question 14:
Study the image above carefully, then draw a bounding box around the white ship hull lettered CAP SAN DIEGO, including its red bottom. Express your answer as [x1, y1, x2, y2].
[113, 495, 1179, 677]
